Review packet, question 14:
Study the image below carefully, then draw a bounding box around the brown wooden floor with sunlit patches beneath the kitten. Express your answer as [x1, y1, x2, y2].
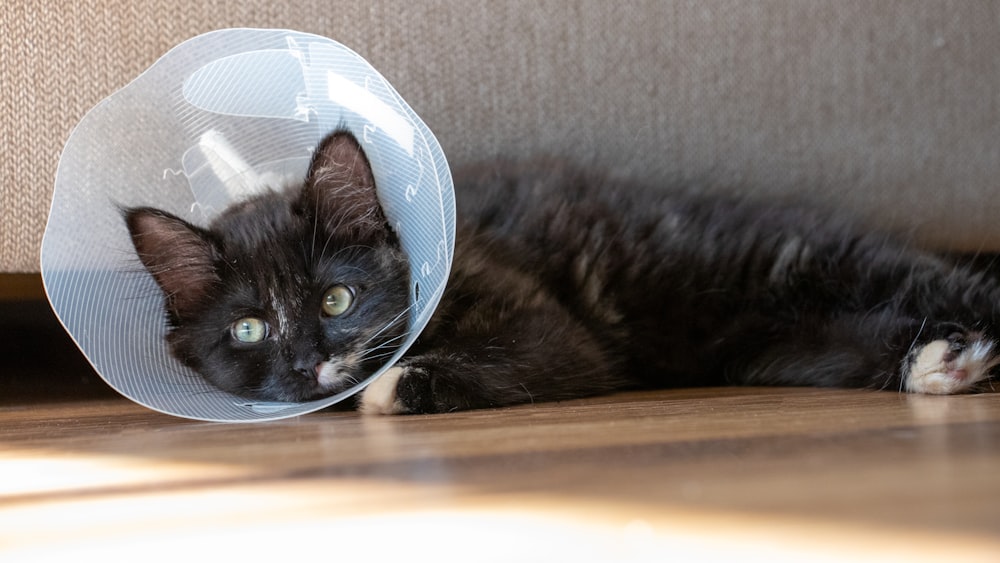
[0, 290, 1000, 562]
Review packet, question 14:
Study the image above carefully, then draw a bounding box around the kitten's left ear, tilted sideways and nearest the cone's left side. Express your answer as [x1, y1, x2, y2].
[124, 207, 220, 318]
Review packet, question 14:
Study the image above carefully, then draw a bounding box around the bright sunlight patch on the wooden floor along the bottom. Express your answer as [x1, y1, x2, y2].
[0, 451, 1000, 562]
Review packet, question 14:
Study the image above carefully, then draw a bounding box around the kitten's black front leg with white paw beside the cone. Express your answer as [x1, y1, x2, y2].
[359, 239, 636, 414]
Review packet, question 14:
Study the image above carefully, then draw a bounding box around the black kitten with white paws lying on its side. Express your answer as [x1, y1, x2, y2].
[124, 131, 1000, 414]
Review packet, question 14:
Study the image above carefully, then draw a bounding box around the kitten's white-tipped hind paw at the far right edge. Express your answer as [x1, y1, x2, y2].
[903, 332, 1000, 395]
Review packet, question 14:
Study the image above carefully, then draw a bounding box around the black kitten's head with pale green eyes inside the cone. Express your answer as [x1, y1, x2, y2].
[125, 132, 409, 401]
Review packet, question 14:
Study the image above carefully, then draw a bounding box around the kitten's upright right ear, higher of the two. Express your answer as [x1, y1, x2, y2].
[302, 131, 390, 239]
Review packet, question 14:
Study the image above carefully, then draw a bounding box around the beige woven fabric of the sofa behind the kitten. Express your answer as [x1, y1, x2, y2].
[0, 0, 1000, 272]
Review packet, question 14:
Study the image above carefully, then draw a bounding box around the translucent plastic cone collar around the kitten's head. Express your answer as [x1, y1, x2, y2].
[41, 29, 455, 422]
